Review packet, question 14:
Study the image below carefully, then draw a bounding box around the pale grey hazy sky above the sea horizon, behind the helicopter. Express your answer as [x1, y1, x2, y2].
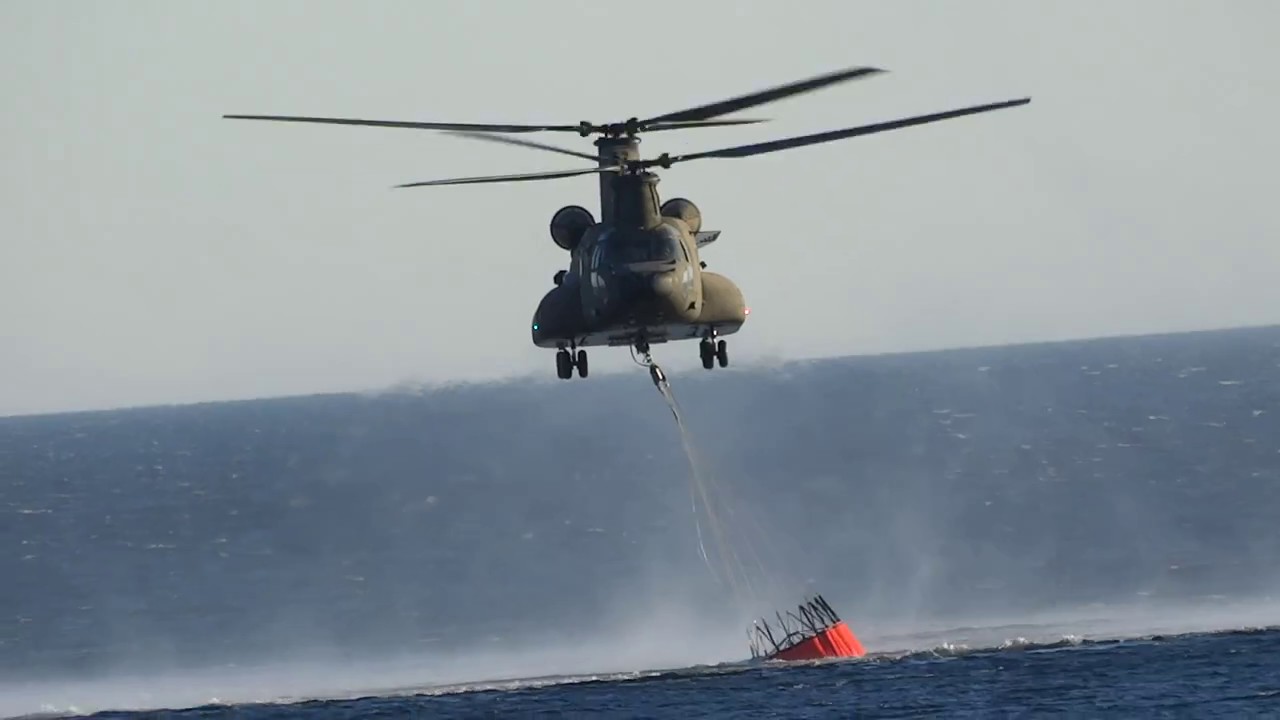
[0, 0, 1280, 414]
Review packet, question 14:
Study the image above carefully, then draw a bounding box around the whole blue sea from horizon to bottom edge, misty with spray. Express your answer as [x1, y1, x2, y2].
[0, 328, 1280, 719]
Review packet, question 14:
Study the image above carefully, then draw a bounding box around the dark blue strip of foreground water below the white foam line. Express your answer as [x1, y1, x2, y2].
[62, 632, 1280, 719]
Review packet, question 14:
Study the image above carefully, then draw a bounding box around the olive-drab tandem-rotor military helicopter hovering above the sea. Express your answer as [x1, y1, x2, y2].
[223, 67, 1030, 382]
